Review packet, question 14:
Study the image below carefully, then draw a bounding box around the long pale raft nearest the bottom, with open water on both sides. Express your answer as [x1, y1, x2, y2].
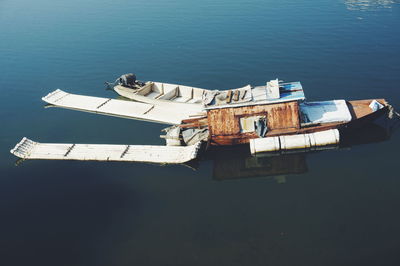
[10, 138, 201, 164]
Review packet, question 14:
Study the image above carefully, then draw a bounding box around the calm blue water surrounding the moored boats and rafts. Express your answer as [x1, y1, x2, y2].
[0, 0, 400, 266]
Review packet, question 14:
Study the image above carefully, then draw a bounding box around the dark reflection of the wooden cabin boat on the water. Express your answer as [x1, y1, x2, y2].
[203, 121, 395, 183]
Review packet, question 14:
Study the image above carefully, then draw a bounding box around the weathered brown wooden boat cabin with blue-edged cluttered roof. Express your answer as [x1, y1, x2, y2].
[206, 80, 305, 145]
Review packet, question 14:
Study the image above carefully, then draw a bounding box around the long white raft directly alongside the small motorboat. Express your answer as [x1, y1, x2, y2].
[42, 89, 203, 125]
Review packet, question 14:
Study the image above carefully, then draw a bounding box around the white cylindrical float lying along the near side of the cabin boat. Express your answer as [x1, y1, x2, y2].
[250, 129, 340, 154]
